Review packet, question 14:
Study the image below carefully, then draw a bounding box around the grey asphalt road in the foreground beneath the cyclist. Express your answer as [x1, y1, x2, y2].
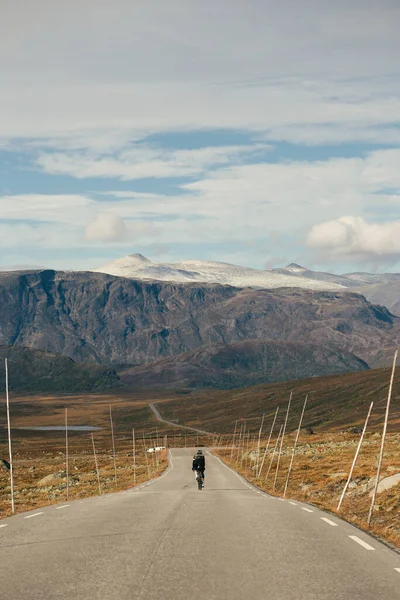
[0, 450, 400, 600]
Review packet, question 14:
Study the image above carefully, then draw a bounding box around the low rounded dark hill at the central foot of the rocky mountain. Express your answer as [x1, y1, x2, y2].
[121, 340, 368, 389]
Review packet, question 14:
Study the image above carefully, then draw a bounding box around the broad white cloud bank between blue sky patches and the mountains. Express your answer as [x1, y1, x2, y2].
[0, 150, 400, 262]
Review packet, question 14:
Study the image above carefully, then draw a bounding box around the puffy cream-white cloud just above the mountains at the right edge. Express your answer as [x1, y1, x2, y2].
[307, 216, 400, 263]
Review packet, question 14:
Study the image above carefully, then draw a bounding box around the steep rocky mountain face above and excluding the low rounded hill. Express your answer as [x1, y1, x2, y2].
[0, 271, 400, 381]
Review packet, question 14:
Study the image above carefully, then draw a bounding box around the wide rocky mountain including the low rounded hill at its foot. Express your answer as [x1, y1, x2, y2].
[0, 265, 400, 387]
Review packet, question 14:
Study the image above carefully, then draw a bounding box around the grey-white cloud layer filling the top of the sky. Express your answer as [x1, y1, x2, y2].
[0, 0, 400, 149]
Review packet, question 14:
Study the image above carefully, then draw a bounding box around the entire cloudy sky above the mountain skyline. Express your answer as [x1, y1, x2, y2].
[0, 0, 400, 272]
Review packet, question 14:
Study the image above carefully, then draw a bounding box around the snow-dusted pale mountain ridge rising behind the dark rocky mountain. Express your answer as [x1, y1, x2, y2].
[90, 254, 344, 291]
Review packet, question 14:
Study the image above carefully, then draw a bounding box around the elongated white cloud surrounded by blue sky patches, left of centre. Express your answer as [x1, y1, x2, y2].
[36, 144, 269, 180]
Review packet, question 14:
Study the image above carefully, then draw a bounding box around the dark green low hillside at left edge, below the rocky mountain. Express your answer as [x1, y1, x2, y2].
[0, 346, 120, 393]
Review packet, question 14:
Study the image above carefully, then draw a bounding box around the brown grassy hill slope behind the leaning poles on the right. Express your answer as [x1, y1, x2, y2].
[157, 369, 400, 433]
